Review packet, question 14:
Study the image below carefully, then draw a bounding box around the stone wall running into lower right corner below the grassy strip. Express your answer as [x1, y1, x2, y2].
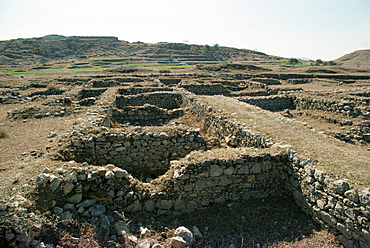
[285, 152, 370, 247]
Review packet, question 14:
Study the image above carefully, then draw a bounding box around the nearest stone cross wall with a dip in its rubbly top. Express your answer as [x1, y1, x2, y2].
[31, 148, 287, 232]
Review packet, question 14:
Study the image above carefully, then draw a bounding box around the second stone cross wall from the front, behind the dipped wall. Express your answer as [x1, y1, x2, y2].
[60, 130, 207, 178]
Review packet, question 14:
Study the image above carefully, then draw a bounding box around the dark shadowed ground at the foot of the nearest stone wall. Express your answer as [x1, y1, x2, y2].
[126, 196, 320, 247]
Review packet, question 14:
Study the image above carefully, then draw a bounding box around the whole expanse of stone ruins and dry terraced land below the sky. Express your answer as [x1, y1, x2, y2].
[0, 37, 370, 248]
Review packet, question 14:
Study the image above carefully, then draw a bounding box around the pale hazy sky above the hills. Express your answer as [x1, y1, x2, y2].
[0, 0, 370, 60]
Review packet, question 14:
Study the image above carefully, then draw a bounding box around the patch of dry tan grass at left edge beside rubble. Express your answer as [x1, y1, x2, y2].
[0, 105, 76, 199]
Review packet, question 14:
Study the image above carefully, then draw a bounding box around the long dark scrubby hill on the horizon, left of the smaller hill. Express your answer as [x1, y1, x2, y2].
[0, 36, 275, 65]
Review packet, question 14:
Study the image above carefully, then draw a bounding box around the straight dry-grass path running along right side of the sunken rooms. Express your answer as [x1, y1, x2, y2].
[197, 96, 370, 189]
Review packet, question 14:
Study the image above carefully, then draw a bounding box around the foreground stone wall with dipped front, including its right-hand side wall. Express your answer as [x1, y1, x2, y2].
[32, 146, 370, 247]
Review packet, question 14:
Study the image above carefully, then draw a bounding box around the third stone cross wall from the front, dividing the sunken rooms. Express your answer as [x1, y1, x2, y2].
[111, 104, 184, 125]
